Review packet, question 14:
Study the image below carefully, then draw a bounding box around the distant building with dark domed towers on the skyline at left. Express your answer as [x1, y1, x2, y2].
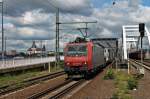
[27, 41, 46, 55]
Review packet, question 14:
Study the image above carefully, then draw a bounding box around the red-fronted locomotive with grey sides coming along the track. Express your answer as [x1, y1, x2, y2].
[64, 37, 112, 77]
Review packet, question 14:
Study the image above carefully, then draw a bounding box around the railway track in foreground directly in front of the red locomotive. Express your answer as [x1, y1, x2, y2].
[27, 79, 85, 99]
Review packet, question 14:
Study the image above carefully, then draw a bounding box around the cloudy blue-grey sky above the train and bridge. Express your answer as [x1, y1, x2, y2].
[0, 0, 150, 50]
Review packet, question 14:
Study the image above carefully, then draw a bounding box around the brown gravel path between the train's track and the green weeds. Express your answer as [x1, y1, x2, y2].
[70, 69, 115, 99]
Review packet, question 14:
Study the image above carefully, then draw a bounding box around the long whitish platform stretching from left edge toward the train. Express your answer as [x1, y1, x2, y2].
[0, 56, 64, 73]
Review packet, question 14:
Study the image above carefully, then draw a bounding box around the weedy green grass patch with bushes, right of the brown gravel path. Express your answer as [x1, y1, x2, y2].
[104, 69, 141, 99]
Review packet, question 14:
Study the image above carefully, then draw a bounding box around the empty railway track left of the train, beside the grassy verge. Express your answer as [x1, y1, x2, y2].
[0, 71, 65, 95]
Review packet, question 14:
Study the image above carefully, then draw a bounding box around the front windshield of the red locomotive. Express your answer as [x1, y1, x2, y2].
[66, 45, 87, 56]
